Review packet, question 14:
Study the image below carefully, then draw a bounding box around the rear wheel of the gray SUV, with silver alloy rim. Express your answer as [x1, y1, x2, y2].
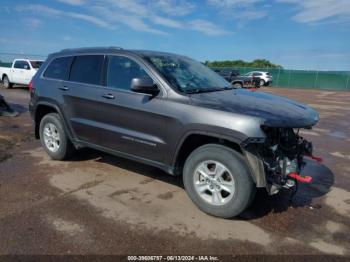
[39, 113, 75, 160]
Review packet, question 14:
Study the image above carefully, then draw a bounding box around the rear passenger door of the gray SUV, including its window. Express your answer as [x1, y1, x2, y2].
[59, 55, 105, 144]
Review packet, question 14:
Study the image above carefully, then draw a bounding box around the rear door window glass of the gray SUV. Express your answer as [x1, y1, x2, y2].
[69, 55, 104, 85]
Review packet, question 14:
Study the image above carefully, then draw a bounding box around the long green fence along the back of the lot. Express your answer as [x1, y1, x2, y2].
[0, 52, 350, 91]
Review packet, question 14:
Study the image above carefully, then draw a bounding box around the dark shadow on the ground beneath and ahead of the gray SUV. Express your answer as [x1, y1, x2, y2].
[70, 148, 334, 220]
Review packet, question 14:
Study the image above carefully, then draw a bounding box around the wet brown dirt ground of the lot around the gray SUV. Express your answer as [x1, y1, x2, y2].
[0, 88, 350, 256]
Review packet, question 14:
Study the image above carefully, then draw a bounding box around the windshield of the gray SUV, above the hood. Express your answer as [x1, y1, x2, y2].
[146, 55, 232, 93]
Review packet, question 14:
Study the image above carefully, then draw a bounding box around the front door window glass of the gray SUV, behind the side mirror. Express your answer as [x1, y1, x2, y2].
[107, 56, 150, 90]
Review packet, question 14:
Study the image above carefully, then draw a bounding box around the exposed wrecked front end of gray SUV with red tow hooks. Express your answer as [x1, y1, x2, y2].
[243, 126, 320, 195]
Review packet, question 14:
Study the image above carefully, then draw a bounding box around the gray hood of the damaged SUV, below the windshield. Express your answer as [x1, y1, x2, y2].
[191, 89, 319, 128]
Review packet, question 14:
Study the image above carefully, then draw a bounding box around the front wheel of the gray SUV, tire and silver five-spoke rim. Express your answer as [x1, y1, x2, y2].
[183, 144, 256, 218]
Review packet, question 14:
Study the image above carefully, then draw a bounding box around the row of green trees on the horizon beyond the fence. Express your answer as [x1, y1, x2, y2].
[204, 59, 283, 68]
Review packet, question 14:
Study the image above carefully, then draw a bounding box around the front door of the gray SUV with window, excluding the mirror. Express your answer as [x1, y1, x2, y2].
[95, 55, 166, 162]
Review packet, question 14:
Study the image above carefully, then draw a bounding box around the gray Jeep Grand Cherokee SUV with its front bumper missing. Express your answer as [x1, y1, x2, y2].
[29, 47, 319, 218]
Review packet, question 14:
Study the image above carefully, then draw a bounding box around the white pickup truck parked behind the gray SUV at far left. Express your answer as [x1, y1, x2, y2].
[0, 59, 43, 88]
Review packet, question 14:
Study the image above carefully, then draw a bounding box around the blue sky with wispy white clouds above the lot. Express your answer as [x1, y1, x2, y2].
[0, 0, 350, 71]
